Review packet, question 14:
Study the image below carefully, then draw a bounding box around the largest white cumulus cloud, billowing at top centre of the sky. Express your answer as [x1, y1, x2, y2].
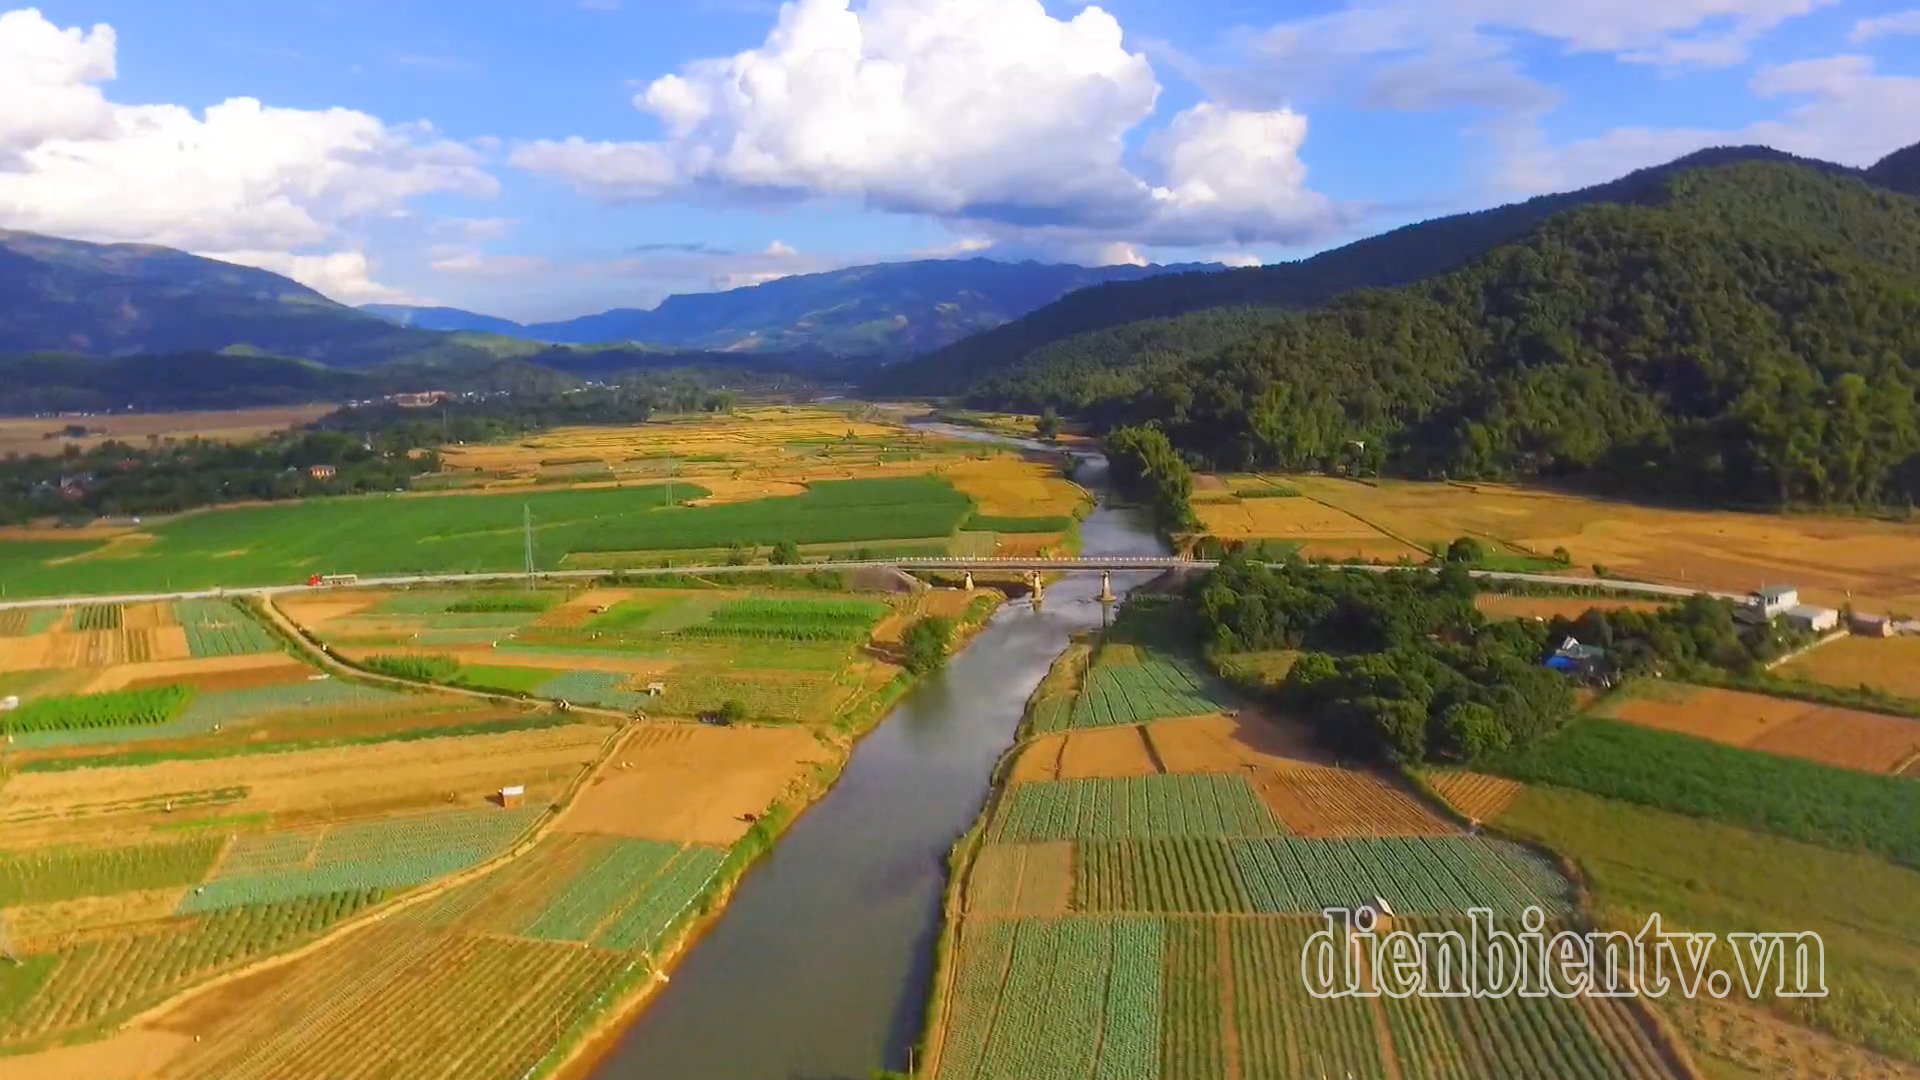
[513, 0, 1332, 244]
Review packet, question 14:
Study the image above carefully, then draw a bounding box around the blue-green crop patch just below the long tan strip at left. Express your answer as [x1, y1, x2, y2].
[180, 807, 543, 915]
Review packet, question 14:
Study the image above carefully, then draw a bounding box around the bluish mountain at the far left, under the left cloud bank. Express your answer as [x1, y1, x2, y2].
[0, 231, 451, 367]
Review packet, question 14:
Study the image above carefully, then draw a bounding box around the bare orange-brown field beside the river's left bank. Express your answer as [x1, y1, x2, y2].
[559, 723, 829, 844]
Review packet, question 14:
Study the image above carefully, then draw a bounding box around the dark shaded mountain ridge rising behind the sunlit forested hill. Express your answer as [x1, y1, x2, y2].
[876, 146, 1853, 394]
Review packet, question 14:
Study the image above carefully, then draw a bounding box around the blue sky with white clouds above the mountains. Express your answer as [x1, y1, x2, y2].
[0, 0, 1920, 319]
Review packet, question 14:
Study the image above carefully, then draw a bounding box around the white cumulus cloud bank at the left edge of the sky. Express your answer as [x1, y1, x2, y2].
[0, 8, 495, 296]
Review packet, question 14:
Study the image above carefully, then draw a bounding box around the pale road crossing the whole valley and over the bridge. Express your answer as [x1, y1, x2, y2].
[0, 555, 1745, 611]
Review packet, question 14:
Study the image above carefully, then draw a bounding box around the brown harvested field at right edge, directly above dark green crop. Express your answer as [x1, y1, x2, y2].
[1605, 684, 1920, 773]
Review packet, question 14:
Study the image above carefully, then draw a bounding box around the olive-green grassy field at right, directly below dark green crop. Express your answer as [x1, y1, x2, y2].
[1500, 780, 1920, 1063]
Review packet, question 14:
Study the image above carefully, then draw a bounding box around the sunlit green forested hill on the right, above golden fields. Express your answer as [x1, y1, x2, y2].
[1105, 163, 1920, 505]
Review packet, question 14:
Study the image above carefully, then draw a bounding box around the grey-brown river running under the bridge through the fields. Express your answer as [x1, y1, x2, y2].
[591, 449, 1165, 1080]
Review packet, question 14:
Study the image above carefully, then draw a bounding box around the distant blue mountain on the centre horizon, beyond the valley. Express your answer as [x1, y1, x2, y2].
[520, 259, 1198, 356]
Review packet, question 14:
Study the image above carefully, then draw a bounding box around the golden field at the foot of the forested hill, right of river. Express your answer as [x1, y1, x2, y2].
[1194, 477, 1920, 611]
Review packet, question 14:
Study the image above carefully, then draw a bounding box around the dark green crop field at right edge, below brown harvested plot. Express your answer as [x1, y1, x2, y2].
[1498, 719, 1920, 867]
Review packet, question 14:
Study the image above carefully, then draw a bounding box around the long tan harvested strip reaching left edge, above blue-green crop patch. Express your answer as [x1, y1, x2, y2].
[0, 724, 609, 846]
